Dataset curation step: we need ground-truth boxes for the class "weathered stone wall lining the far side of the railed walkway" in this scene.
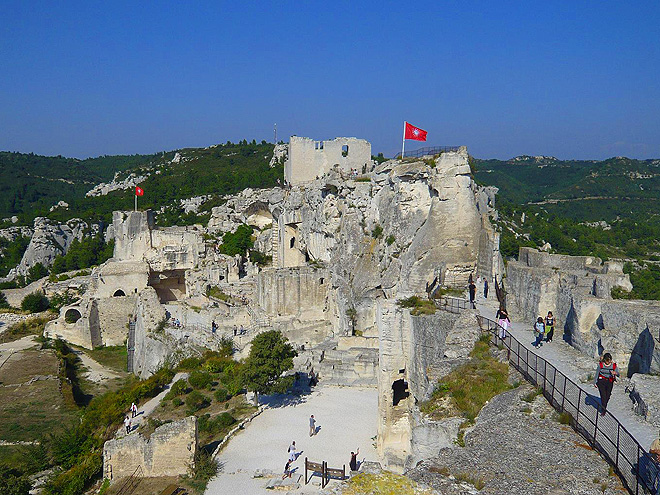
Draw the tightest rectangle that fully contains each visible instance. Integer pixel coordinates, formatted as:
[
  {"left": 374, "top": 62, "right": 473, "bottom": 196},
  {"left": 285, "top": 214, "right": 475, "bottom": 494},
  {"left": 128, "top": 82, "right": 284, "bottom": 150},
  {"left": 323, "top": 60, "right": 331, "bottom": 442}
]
[{"left": 505, "top": 248, "right": 660, "bottom": 374}]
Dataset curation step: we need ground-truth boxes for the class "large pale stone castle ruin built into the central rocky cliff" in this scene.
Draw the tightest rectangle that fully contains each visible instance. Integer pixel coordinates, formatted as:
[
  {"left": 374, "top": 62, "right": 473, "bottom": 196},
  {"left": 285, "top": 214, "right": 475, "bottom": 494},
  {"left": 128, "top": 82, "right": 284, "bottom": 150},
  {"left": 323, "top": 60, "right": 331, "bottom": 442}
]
[{"left": 46, "top": 137, "right": 503, "bottom": 470}]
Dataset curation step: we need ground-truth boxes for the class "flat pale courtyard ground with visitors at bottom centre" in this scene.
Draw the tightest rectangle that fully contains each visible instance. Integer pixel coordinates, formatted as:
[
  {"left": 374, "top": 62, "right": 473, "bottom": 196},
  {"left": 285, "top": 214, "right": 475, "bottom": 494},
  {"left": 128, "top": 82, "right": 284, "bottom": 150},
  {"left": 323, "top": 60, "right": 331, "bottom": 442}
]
[{"left": 206, "top": 386, "right": 378, "bottom": 495}]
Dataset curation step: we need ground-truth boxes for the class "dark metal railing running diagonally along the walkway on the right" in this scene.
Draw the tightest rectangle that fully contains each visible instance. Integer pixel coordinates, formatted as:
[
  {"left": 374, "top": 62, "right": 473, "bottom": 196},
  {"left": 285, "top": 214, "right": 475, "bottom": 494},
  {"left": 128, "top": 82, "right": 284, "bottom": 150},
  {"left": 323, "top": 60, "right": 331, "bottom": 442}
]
[{"left": 477, "top": 315, "right": 660, "bottom": 495}]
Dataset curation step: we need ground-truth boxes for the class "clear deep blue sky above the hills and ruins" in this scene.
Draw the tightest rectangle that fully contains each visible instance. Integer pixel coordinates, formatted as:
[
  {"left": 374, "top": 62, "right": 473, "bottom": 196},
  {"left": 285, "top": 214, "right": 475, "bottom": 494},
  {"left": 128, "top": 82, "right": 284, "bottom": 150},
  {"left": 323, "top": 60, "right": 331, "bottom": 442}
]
[{"left": 0, "top": 0, "right": 660, "bottom": 159}]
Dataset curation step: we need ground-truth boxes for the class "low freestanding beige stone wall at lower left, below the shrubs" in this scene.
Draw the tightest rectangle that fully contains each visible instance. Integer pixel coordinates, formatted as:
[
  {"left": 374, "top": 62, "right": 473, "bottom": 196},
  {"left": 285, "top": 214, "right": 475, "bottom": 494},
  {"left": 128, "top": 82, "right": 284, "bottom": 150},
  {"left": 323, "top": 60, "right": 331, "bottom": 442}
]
[{"left": 103, "top": 416, "right": 197, "bottom": 483}]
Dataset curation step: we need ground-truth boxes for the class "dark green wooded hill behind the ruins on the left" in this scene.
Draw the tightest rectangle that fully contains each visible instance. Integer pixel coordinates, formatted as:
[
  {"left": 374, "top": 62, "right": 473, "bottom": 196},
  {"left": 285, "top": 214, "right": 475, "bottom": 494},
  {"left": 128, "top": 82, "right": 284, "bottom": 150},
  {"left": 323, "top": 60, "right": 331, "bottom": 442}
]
[{"left": 0, "top": 140, "right": 283, "bottom": 228}]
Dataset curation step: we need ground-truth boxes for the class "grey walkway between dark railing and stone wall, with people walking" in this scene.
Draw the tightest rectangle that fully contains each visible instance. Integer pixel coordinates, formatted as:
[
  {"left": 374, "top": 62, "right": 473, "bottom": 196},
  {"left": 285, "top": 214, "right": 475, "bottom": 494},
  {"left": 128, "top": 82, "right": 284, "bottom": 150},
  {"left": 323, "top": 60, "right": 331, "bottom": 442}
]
[{"left": 477, "top": 295, "right": 658, "bottom": 449}]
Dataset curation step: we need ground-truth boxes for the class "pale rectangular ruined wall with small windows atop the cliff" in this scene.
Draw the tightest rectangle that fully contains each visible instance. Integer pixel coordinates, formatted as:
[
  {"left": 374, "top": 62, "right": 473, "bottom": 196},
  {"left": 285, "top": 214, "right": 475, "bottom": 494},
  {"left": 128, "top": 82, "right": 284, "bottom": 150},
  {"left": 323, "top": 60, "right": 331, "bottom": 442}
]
[{"left": 284, "top": 136, "right": 371, "bottom": 185}]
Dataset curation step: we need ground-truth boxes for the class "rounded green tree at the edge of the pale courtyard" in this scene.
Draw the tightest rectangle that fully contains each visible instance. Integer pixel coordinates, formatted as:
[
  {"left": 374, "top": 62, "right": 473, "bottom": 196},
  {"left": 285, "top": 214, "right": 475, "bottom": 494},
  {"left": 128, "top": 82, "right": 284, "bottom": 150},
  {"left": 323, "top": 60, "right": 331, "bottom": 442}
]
[{"left": 241, "top": 330, "right": 298, "bottom": 405}]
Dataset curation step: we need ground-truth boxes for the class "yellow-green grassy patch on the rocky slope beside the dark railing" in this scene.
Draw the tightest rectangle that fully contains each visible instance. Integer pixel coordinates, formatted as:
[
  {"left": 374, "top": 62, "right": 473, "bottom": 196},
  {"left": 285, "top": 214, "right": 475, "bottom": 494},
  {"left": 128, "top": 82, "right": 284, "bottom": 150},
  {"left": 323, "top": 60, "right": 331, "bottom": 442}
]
[{"left": 420, "top": 335, "right": 511, "bottom": 422}]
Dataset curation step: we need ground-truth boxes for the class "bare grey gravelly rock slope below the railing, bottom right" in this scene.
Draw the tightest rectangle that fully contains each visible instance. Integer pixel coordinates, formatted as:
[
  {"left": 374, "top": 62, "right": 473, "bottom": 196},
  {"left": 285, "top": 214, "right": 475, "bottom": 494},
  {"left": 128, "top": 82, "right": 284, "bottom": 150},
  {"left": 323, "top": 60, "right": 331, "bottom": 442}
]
[{"left": 407, "top": 384, "right": 621, "bottom": 495}]
